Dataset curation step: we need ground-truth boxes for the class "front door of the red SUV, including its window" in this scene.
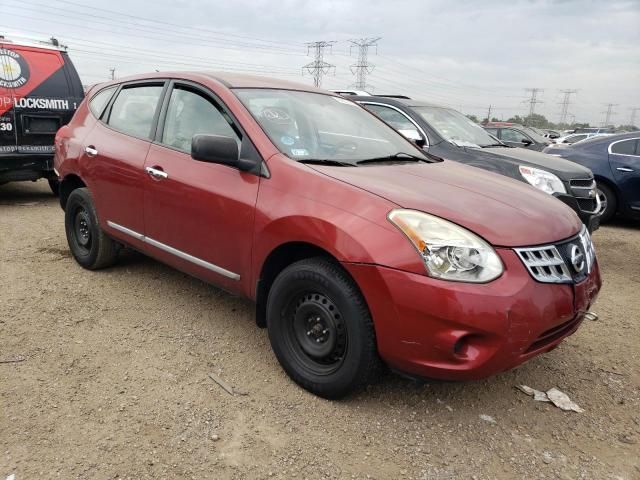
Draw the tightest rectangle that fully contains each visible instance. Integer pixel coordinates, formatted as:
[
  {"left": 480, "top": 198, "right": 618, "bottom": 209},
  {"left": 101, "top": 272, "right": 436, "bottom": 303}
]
[{"left": 144, "top": 82, "right": 259, "bottom": 292}]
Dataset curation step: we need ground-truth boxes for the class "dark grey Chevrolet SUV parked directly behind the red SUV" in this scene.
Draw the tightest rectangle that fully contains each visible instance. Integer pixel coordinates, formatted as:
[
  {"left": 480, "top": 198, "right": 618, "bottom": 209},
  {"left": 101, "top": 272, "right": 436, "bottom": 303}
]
[{"left": 349, "top": 95, "right": 599, "bottom": 231}]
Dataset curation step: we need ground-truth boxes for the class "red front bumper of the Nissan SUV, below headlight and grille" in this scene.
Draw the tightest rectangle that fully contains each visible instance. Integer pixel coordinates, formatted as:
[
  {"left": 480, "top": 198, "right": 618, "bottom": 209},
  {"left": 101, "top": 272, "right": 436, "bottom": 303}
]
[{"left": 344, "top": 249, "right": 601, "bottom": 380}]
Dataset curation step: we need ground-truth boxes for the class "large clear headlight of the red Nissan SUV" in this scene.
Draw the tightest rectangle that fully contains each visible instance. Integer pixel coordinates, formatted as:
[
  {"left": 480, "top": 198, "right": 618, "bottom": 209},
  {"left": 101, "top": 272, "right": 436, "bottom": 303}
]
[{"left": 389, "top": 210, "right": 504, "bottom": 283}]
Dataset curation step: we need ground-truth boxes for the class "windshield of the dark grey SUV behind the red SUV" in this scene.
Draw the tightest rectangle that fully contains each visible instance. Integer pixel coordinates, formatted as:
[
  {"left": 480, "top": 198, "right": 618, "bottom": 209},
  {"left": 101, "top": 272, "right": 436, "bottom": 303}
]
[{"left": 412, "top": 106, "right": 499, "bottom": 147}]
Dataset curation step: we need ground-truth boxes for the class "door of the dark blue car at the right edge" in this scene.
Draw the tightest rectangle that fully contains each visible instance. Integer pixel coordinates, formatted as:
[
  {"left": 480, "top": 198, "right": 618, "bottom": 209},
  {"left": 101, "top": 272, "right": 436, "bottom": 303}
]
[{"left": 609, "top": 137, "right": 640, "bottom": 210}]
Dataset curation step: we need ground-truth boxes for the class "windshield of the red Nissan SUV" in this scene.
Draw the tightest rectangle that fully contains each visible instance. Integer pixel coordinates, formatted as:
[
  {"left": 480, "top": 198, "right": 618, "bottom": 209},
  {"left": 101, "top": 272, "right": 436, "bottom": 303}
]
[{"left": 234, "top": 88, "right": 430, "bottom": 166}]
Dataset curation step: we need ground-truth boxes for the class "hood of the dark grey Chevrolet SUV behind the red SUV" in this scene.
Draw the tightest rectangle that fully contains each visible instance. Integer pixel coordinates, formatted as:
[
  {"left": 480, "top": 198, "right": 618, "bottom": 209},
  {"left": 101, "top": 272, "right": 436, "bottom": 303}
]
[{"left": 474, "top": 145, "right": 593, "bottom": 180}]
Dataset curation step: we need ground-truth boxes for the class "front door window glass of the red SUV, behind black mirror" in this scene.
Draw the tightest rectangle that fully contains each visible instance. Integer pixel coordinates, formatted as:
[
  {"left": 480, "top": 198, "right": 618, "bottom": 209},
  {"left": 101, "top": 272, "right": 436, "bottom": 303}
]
[{"left": 162, "top": 87, "right": 240, "bottom": 154}]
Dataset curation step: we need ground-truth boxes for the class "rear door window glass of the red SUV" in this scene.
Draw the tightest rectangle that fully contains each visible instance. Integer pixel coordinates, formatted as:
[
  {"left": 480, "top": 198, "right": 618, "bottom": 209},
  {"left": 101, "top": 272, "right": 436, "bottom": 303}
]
[{"left": 107, "top": 85, "right": 163, "bottom": 139}]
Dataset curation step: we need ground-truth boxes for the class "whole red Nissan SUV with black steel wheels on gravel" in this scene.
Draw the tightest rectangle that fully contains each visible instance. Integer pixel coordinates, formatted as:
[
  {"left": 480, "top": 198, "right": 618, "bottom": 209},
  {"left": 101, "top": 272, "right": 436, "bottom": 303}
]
[{"left": 55, "top": 73, "right": 601, "bottom": 398}]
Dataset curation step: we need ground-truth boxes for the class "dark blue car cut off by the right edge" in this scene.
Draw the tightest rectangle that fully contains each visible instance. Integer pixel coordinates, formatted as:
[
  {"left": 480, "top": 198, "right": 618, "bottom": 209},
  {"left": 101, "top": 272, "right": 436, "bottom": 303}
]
[{"left": 545, "top": 132, "right": 640, "bottom": 223}]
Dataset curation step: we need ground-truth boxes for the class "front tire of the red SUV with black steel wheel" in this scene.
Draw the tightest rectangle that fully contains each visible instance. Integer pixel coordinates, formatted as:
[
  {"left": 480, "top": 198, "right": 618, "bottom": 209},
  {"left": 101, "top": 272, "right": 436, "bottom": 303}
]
[{"left": 267, "top": 257, "right": 382, "bottom": 399}]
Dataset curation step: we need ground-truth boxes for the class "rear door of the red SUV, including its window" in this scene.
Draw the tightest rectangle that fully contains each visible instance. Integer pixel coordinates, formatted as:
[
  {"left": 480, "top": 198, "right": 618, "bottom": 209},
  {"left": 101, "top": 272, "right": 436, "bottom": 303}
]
[{"left": 80, "top": 81, "right": 166, "bottom": 244}]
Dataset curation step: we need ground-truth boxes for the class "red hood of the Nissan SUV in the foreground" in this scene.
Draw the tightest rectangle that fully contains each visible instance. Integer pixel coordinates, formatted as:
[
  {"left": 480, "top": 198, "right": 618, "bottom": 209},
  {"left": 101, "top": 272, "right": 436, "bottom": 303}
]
[{"left": 310, "top": 160, "right": 582, "bottom": 247}]
